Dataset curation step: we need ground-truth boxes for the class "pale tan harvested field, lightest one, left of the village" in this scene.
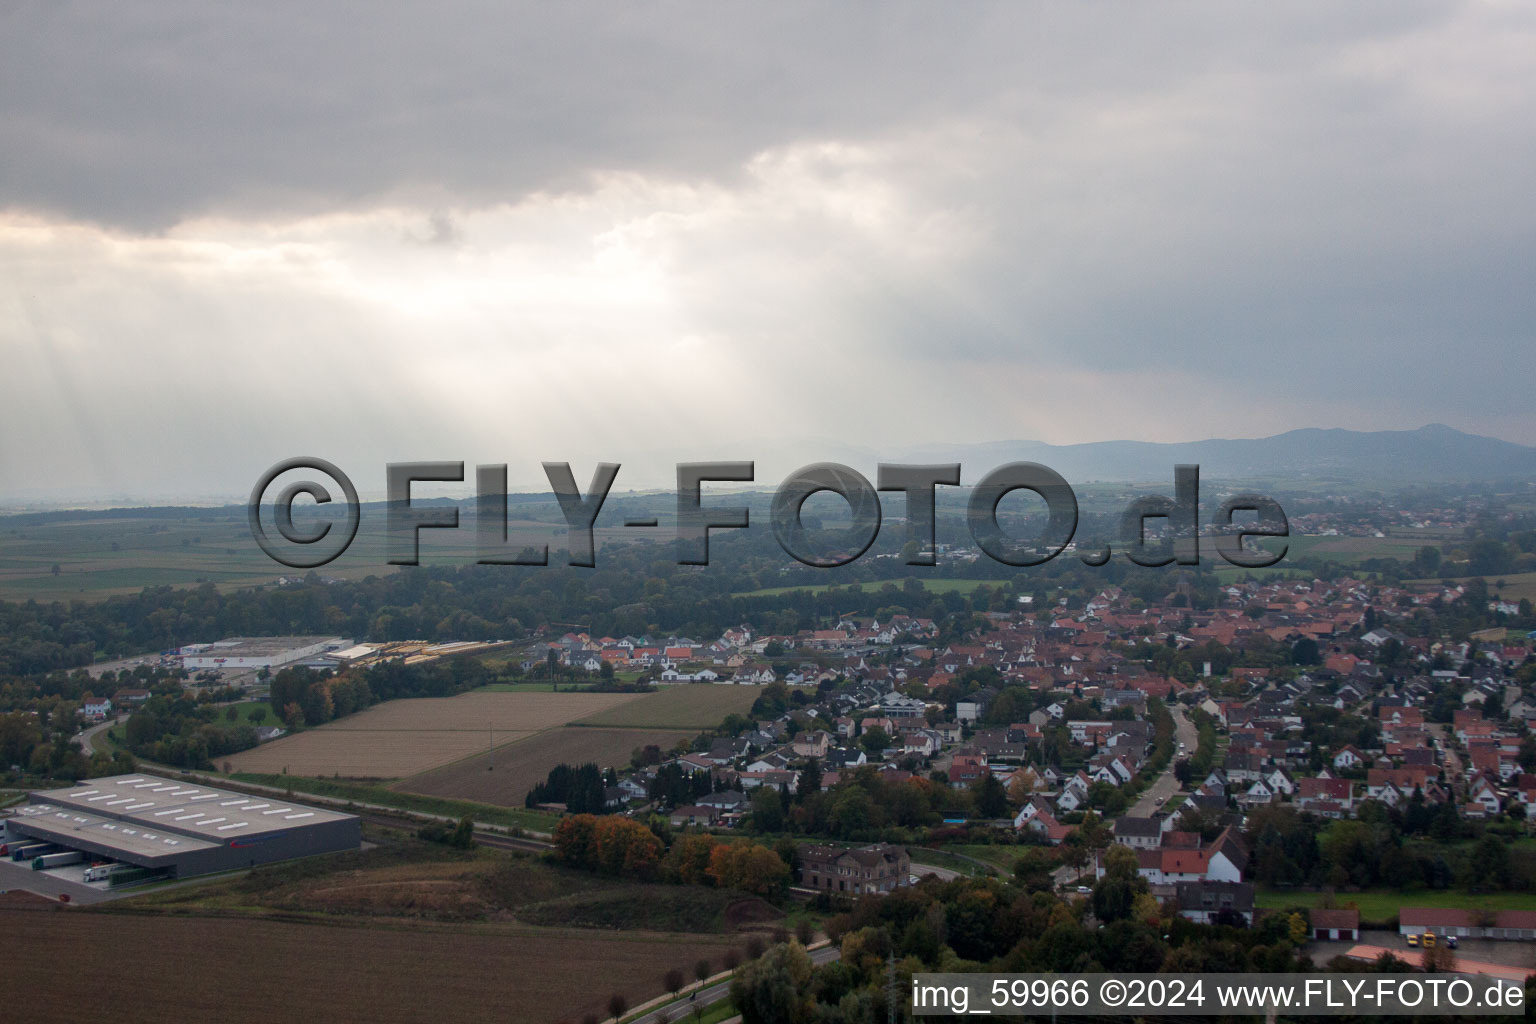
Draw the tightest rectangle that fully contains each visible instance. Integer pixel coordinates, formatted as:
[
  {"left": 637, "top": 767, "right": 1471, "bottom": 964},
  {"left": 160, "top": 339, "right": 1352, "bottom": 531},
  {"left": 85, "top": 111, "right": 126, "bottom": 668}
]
[{"left": 226, "top": 691, "right": 642, "bottom": 779}]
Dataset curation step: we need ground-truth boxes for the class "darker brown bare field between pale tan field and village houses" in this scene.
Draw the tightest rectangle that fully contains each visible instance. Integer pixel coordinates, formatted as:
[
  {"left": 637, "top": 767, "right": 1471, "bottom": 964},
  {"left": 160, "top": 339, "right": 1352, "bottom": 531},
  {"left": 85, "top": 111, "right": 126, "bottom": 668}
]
[{"left": 395, "top": 726, "right": 697, "bottom": 808}]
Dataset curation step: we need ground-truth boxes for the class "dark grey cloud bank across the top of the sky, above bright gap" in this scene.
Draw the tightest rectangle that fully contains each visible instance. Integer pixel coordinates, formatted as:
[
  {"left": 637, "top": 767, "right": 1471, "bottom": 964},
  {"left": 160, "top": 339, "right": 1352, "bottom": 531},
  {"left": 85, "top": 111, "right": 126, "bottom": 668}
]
[{"left": 0, "top": 3, "right": 1444, "bottom": 229}]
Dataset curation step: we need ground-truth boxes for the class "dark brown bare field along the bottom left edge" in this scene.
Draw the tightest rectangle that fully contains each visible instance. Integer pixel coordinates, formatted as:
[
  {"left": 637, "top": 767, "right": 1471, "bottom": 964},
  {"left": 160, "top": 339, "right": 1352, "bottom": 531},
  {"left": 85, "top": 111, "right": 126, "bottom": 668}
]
[{"left": 0, "top": 907, "right": 734, "bottom": 1024}]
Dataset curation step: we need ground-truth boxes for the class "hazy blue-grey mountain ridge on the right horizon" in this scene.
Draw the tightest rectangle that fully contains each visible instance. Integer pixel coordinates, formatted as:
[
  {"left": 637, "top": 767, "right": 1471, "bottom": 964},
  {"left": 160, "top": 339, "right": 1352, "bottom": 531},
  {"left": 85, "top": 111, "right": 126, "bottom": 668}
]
[{"left": 871, "top": 424, "right": 1536, "bottom": 485}]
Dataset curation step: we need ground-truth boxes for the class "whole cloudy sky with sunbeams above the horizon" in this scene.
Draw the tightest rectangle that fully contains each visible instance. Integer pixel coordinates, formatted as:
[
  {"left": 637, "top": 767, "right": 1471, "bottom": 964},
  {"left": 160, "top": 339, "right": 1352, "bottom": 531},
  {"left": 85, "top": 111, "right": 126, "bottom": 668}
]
[{"left": 0, "top": 0, "right": 1536, "bottom": 504}]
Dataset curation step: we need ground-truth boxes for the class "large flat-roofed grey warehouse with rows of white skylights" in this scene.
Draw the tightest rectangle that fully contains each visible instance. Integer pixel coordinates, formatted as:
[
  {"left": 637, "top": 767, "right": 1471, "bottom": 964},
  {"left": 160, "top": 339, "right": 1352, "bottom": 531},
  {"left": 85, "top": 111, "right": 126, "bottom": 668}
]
[{"left": 5, "top": 774, "right": 362, "bottom": 878}]
